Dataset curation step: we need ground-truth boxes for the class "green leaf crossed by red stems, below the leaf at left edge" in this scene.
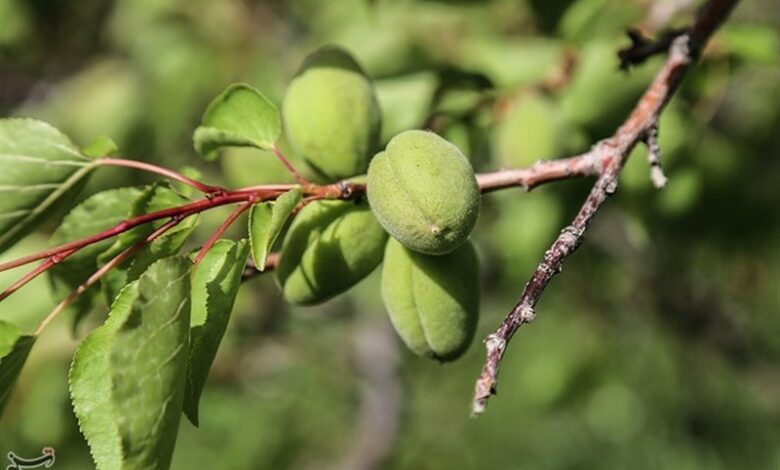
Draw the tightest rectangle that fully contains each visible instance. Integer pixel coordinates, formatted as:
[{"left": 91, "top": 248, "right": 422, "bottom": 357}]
[{"left": 48, "top": 187, "right": 141, "bottom": 330}]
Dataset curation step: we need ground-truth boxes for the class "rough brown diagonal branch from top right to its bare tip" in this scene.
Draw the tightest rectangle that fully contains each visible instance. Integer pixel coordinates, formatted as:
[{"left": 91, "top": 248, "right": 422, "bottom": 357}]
[{"left": 472, "top": 0, "right": 739, "bottom": 414}]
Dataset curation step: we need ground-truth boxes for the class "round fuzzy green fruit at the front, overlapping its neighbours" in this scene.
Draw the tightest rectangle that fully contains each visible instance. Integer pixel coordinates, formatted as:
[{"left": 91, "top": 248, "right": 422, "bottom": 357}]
[{"left": 368, "top": 130, "right": 480, "bottom": 255}]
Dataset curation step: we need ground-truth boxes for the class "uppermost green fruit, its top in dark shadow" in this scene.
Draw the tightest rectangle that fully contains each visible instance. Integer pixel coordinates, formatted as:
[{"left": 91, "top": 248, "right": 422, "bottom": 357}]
[{"left": 282, "top": 47, "right": 381, "bottom": 181}]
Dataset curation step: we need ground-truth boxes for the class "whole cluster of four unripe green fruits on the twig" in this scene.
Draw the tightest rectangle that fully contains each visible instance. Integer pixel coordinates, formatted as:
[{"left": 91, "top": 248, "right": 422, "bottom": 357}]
[{"left": 277, "top": 47, "right": 480, "bottom": 361}]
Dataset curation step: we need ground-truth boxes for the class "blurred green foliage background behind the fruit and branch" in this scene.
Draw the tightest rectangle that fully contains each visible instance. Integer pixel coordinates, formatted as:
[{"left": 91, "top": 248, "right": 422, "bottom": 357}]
[{"left": 0, "top": 0, "right": 780, "bottom": 469}]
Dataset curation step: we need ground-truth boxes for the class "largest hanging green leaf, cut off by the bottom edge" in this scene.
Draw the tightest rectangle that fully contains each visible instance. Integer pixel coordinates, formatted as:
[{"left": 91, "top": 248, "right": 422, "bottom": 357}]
[{"left": 70, "top": 257, "right": 191, "bottom": 470}]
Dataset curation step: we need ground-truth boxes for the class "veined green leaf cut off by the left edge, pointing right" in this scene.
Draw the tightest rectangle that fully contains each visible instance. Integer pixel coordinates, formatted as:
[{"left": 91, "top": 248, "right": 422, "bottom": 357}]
[{"left": 0, "top": 118, "right": 93, "bottom": 252}]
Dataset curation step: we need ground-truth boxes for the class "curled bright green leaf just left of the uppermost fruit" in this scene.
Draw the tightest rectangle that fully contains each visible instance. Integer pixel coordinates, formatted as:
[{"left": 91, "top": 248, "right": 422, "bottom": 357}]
[{"left": 193, "top": 83, "right": 282, "bottom": 159}]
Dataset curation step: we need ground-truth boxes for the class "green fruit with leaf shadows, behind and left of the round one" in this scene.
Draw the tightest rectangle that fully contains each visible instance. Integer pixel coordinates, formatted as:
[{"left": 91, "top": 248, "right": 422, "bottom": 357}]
[{"left": 276, "top": 201, "right": 387, "bottom": 305}]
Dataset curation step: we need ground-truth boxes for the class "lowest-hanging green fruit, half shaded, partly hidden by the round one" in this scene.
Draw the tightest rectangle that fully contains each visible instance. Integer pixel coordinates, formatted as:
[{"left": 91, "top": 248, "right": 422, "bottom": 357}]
[{"left": 382, "top": 239, "right": 479, "bottom": 362}]
